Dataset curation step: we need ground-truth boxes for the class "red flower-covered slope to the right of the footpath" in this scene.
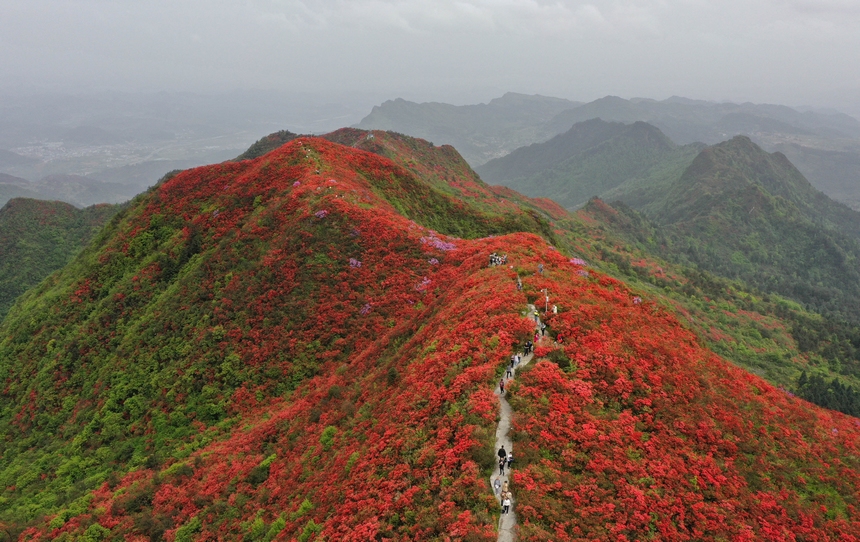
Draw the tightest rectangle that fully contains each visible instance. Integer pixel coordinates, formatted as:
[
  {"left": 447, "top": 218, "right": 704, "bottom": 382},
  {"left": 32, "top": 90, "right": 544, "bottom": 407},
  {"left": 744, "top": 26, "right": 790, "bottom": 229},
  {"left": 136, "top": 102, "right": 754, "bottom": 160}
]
[{"left": 508, "top": 251, "right": 860, "bottom": 540}]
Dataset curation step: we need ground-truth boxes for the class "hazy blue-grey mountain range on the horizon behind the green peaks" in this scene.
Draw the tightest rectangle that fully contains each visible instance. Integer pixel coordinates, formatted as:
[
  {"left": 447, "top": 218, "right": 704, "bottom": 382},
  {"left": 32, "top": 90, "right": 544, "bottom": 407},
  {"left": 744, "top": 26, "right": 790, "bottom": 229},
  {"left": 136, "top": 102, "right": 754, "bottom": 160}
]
[{"left": 357, "top": 94, "right": 860, "bottom": 208}]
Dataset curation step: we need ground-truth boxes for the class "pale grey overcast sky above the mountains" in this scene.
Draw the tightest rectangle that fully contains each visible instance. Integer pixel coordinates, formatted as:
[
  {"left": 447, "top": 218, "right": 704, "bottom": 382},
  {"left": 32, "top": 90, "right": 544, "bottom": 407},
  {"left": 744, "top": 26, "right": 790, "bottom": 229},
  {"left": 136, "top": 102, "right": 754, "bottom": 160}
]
[{"left": 0, "top": 0, "right": 860, "bottom": 111}]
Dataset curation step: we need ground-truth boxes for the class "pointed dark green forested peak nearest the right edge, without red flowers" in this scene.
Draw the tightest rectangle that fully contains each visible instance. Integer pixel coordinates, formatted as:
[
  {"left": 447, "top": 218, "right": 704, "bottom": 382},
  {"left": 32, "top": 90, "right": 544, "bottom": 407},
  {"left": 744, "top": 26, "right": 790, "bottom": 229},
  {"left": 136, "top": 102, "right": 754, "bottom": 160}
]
[{"left": 644, "top": 137, "right": 860, "bottom": 322}]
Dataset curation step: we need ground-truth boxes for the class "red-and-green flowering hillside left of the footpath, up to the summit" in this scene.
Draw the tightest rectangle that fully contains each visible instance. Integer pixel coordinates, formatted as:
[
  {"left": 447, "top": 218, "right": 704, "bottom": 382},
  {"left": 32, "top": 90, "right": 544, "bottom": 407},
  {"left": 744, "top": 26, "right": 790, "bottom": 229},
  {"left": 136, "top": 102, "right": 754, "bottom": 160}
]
[{"left": 0, "top": 139, "right": 544, "bottom": 539}]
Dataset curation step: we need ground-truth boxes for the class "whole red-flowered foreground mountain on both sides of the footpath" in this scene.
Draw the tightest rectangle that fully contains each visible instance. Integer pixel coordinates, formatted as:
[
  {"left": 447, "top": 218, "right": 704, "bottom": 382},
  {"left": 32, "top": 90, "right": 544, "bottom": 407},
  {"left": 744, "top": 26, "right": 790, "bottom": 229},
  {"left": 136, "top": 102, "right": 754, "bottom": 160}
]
[{"left": 0, "top": 136, "right": 860, "bottom": 541}]
